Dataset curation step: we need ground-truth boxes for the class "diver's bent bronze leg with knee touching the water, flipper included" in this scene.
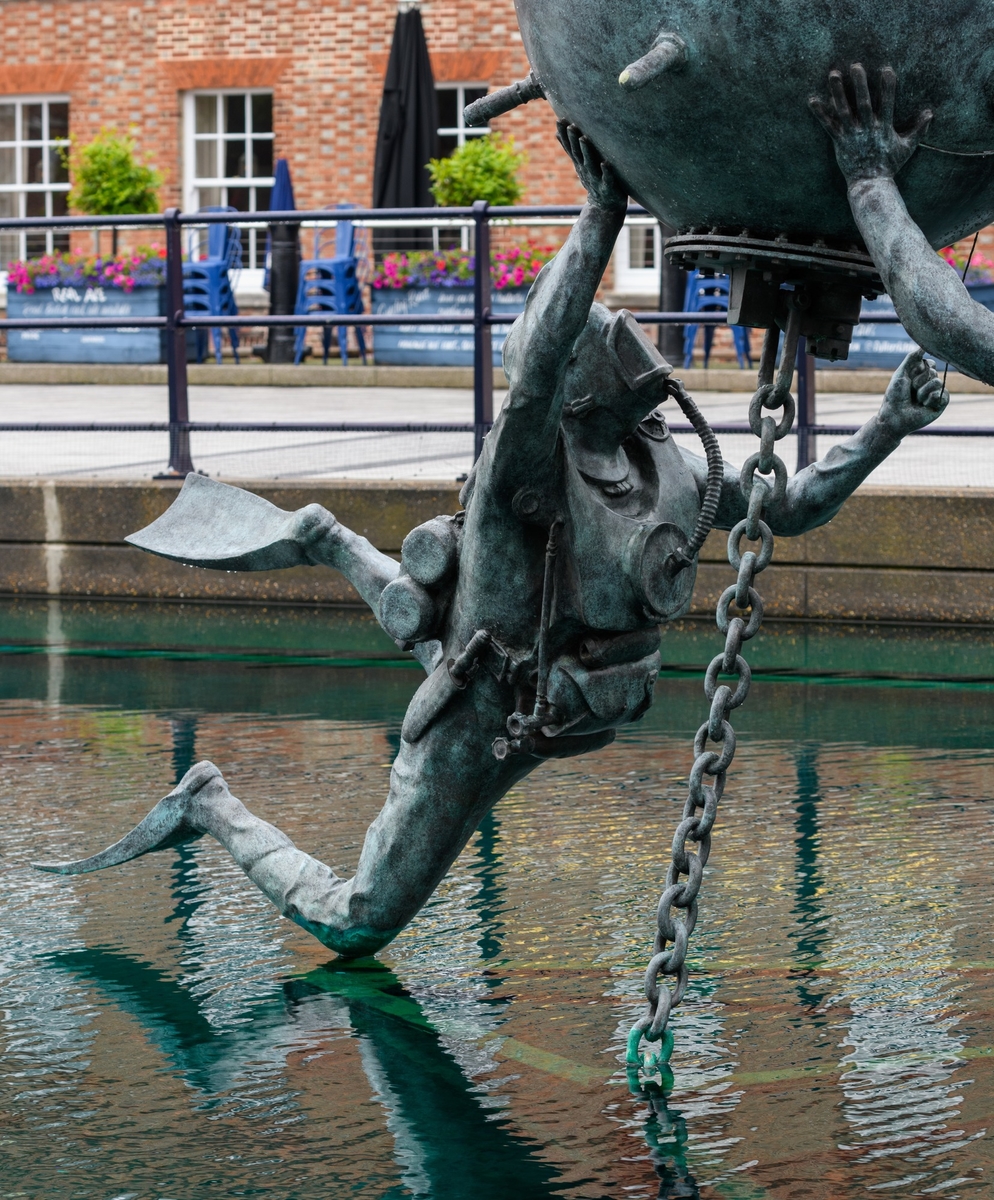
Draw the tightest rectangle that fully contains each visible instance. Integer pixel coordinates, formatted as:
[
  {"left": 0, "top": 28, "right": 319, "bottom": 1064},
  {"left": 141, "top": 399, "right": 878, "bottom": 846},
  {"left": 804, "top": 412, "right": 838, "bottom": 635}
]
[{"left": 36, "top": 676, "right": 538, "bottom": 956}]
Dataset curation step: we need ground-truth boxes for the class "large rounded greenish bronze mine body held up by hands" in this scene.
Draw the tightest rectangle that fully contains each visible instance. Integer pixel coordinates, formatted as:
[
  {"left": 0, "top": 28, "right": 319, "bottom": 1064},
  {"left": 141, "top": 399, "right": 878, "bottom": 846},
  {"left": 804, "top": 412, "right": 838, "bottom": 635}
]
[{"left": 504, "top": 0, "right": 994, "bottom": 247}]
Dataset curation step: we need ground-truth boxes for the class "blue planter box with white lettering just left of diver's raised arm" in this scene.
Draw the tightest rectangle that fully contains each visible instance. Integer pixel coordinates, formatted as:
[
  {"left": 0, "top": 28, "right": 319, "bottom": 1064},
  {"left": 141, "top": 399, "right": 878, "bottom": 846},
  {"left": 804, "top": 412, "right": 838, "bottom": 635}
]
[{"left": 372, "top": 288, "right": 528, "bottom": 367}]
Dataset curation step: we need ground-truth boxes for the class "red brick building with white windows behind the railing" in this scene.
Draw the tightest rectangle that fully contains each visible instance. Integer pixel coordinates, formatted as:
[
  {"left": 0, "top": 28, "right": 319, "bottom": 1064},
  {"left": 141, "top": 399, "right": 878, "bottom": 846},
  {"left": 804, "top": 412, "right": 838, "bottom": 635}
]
[{"left": 0, "top": 0, "right": 658, "bottom": 304}]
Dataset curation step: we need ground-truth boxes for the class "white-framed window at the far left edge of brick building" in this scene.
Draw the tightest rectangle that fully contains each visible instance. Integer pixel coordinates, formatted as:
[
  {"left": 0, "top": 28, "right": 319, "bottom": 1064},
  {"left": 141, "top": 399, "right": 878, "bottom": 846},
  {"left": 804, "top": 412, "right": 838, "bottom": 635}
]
[{"left": 0, "top": 96, "right": 70, "bottom": 268}]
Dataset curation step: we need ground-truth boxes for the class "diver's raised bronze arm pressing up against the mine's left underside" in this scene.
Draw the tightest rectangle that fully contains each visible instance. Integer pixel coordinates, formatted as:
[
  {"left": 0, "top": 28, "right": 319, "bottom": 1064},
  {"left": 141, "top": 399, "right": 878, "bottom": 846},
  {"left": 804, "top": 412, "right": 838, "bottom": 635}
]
[{"left": 499, "top": 121, "right": 628, "bottom": 477}]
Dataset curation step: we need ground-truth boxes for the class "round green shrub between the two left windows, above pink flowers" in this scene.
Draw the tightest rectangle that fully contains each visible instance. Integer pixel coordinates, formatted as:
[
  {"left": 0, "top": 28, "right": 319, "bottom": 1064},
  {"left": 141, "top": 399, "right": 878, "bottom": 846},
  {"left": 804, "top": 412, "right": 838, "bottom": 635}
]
[{"left": 68, "top": 130, "right": 162, "bottom": 216}]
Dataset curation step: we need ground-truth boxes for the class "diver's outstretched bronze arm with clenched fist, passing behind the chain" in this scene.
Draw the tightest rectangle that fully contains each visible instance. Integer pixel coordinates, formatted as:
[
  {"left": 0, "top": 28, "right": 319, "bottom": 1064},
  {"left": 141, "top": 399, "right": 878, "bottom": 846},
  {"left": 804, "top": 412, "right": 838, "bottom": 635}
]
[{"left": 683, "top": 350, "right": 950, "bottom": 538}]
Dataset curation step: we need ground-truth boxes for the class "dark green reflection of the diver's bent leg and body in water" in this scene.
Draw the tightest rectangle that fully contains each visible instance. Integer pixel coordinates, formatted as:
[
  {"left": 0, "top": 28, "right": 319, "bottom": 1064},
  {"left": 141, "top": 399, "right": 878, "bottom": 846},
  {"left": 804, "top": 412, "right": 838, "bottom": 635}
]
[{"left": 48, "top": 948, "right": 566, "bottom": 1200}]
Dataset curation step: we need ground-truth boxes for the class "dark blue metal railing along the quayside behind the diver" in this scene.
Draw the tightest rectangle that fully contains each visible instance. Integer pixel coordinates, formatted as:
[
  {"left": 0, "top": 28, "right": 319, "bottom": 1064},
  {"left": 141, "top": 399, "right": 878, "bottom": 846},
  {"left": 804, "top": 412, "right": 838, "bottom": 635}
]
[{"left": 0, "top": 200, "right": 979, "bottom": 476}]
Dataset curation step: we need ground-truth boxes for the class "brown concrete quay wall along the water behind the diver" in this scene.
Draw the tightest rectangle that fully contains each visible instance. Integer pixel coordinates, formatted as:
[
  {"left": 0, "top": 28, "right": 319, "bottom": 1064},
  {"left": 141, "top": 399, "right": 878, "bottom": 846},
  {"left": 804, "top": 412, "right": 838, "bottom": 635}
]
[{"left": 0, "top": 479, "right": 994, "bottom": 625}]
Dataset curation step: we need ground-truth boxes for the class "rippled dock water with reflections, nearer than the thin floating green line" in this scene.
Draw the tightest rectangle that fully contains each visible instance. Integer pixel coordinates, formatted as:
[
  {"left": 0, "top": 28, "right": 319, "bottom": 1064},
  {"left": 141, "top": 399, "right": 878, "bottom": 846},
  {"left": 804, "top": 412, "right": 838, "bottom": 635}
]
[{"left": 0, "top": 609, "right": 994, "bottom": 1200}]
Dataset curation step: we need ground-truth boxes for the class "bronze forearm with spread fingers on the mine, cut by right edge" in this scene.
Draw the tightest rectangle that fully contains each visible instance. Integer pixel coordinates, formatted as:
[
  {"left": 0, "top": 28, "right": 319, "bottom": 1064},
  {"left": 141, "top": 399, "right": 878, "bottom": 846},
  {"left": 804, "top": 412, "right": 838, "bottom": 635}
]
[{"left": 810, "top": 62, "right": 994, "bottom": 383}]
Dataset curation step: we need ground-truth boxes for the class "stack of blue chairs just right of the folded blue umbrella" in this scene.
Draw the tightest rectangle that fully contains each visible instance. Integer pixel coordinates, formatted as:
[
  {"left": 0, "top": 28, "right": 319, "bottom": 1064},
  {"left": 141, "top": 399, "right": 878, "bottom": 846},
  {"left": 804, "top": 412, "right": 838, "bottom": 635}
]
[{"left": 294, "top": 204, "right": 366, "bottom": 366}]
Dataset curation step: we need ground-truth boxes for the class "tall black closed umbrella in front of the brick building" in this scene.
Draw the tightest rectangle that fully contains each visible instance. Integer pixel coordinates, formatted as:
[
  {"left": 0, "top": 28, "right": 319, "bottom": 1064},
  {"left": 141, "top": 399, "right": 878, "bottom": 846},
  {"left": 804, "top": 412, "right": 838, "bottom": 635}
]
[{"left": 373, "top": 5, "right": 438, "bottom": 251}]
